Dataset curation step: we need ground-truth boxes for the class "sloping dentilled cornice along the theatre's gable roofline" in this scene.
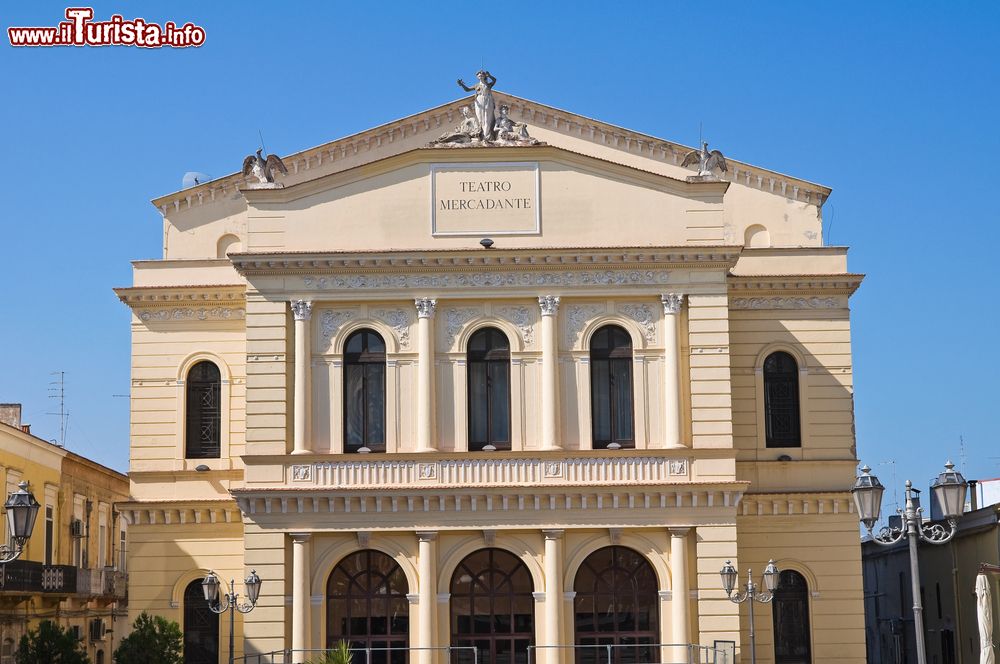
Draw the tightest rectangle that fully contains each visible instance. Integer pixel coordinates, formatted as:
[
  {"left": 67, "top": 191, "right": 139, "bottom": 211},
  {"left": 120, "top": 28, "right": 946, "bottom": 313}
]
[{"left": 152, "top": 90, "right": 831, "bottom": 216}]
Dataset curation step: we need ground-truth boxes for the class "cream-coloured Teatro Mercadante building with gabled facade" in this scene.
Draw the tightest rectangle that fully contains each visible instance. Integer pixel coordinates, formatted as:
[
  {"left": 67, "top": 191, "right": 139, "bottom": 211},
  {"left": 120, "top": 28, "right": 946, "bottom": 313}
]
[{"left": 116, "top": 85, "right": 865, "bottom": 664}]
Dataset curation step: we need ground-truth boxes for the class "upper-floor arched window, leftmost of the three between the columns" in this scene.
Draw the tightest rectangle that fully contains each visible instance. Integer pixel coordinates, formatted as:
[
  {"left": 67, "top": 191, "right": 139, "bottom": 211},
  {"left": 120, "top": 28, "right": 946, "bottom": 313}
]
[{"left": 344, "top": 330, "right": 385, "bottom": 452}]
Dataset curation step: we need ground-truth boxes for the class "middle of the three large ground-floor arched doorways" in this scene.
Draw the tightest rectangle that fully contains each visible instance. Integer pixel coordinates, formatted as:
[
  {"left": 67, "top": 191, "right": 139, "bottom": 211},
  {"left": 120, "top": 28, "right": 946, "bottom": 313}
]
[{"left": 451, "top": 549, "right": 535, "bottom": 664}]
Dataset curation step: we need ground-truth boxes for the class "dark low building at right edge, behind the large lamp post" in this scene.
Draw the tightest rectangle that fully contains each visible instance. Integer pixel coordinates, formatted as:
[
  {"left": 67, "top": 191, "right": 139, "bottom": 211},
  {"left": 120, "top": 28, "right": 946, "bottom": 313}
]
[{"left": 861, "top": 498, "right": 1000, "bottom": 664}]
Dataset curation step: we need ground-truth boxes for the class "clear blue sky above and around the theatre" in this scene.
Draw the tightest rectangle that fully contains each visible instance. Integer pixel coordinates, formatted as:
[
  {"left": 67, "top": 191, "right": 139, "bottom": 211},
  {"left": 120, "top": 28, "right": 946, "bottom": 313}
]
[{"left": 0, "top": 2, "right": 1000, "bottom": 504}]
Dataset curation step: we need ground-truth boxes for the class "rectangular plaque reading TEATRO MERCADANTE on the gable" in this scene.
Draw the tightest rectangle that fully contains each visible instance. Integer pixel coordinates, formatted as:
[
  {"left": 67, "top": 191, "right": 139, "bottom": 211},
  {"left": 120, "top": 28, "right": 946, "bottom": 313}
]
[{"left": 431, "top": 162, "right": 541, "bottom": 237}]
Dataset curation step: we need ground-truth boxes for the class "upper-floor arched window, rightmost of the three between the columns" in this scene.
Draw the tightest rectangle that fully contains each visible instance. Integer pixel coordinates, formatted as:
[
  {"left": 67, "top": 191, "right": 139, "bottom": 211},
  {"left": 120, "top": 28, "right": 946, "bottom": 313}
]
[{"left": 590, "top": 325, "right": 635, "bottom": 449}]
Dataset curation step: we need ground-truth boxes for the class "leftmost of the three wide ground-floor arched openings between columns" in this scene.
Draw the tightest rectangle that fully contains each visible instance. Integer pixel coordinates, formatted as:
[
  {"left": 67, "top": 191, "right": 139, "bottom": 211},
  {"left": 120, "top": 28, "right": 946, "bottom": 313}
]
[{"left": 326, "top": 549, "right": 410, "bottom": 664}]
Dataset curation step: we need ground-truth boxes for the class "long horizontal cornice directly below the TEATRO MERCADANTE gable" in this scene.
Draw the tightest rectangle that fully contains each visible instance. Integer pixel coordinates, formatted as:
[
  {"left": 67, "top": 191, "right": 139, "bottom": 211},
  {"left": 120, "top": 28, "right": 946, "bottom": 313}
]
[{"left": 230, "top": 246, "right": 740, "bottom": 276}]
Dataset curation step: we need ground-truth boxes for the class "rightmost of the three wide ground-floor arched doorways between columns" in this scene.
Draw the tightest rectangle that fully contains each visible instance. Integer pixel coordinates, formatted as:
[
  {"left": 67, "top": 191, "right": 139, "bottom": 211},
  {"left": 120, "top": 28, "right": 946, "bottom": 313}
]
[{"left": 573, "top": 546, "right": 660, "bottom": 664}]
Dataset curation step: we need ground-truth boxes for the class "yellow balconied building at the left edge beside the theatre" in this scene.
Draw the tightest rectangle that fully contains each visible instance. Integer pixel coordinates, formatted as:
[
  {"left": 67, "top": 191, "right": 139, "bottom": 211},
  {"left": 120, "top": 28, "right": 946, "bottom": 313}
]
[{"left": 0, "top": 404, "right": 128, "bottom": 664}]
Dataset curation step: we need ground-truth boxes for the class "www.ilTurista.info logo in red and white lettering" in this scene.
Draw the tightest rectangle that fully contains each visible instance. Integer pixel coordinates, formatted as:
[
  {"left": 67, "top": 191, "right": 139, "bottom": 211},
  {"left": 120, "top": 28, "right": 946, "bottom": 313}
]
[{"left": 7, "top": 7, "right": 205, "bottom": 48}]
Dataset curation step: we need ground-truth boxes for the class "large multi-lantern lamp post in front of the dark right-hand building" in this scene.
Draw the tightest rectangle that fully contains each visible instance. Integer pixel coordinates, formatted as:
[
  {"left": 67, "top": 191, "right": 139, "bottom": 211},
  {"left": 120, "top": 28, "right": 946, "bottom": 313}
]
[{"left": 851, "top": 461, "right": 968, "bottom": 664}]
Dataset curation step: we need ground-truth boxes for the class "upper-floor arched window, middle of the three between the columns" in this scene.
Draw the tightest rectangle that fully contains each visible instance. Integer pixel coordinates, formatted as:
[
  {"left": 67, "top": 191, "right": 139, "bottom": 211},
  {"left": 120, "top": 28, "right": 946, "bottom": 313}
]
[{"left": 468, "top": 327, "right": 510, "bottom": 450}]
